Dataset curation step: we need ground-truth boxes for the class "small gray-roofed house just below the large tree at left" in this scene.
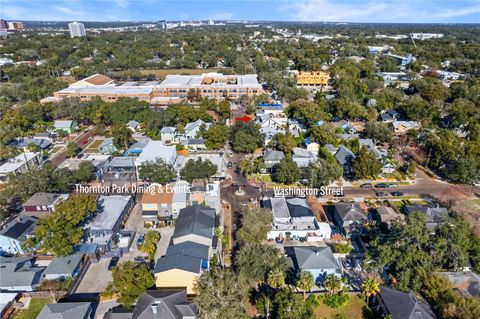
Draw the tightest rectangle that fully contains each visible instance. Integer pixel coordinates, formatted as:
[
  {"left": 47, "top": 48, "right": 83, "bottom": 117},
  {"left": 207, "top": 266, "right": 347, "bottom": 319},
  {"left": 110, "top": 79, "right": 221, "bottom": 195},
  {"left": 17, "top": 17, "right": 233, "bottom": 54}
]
[{"left": 43, "top": 254, "right": 83, "bottom": 280}]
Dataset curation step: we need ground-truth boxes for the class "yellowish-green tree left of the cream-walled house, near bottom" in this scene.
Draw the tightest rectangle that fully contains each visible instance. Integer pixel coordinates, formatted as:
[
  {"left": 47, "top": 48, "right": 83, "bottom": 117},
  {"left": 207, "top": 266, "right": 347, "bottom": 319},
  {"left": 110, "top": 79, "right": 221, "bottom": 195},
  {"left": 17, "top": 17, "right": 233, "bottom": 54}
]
[{"left": 102, "top": 261, "right": 155, "bottom": 307}]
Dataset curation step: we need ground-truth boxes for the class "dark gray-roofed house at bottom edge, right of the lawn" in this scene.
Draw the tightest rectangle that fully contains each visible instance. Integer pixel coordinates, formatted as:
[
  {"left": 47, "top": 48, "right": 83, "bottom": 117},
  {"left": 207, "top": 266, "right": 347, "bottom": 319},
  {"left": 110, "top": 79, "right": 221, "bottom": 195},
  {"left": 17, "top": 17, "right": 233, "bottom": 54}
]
[{"left": 374, "top": 285, "right": 437, "bottom": 319}]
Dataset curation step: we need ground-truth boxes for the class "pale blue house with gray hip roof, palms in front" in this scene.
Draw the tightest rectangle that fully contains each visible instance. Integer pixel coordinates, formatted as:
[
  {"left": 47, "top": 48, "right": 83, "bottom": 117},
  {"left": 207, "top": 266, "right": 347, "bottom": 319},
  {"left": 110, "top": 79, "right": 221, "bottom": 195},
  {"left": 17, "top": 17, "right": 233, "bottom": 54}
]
[{"left": 285, "top": 246, "right": 343, "bottom": 285}]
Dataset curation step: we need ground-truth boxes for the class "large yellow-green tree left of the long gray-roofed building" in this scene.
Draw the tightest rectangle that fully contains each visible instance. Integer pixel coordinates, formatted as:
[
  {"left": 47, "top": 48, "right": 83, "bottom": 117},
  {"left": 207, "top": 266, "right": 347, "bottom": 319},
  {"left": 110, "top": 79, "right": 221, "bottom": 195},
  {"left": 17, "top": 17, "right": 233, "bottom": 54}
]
[{"left": 25, "top": 195, "right": 96, "bottom": 256}]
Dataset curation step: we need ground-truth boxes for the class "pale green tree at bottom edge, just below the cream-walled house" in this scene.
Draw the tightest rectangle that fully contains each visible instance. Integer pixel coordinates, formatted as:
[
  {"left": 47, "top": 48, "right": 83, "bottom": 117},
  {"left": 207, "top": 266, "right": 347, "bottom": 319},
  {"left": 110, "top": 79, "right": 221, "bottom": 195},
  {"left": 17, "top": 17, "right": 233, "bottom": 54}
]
[{"left": 195, "top": 269, "right": 248, "bottom": 319}]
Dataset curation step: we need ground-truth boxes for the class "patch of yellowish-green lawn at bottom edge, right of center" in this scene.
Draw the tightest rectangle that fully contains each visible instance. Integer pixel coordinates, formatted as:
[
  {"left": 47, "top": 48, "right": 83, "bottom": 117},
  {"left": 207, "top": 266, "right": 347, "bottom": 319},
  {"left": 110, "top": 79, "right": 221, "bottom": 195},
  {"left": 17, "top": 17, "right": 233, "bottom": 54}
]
[{"left": 315, "top": 296, "right": 379, "bottom": 319}]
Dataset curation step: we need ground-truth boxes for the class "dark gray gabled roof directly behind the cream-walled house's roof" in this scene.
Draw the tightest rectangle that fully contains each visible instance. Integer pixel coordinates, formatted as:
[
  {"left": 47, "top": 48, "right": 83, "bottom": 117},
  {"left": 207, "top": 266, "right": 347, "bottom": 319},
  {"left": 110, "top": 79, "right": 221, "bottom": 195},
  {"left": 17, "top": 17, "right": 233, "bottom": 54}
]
[{"left": 172, "top": 205, "right": 215, "bottom": 238}]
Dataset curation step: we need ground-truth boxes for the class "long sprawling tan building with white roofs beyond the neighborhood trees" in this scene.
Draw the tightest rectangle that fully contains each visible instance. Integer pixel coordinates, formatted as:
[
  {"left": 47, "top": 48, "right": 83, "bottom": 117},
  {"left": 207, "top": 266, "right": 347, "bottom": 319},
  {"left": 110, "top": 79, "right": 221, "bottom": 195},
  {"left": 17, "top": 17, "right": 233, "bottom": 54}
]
[{"left": 49, "top": 73, "right": 263, "bottom": 104}]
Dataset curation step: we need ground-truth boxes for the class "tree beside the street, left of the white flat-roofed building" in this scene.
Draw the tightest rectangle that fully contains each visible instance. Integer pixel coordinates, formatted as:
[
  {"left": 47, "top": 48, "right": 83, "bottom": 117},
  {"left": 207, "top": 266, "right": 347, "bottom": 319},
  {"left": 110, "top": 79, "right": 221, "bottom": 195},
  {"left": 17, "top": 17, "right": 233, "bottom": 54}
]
[{"left": 237, "top": 208, "right": 272, "bottom": 245}]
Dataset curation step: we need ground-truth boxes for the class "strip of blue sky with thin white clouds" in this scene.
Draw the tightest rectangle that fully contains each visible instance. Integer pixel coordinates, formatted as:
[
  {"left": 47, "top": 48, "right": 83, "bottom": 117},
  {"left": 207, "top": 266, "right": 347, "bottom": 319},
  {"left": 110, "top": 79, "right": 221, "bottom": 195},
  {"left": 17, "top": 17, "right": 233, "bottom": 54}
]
[{"left": 0, "top": 0, "right": 480, "bottom": 23}]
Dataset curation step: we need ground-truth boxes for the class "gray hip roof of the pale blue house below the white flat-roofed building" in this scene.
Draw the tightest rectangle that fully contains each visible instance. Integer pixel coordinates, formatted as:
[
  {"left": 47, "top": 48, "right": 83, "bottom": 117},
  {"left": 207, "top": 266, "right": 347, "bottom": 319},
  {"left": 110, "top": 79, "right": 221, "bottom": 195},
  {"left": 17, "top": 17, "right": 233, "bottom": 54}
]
[{"left": 293, "top": 246, "right": 340, "bottom": 270}]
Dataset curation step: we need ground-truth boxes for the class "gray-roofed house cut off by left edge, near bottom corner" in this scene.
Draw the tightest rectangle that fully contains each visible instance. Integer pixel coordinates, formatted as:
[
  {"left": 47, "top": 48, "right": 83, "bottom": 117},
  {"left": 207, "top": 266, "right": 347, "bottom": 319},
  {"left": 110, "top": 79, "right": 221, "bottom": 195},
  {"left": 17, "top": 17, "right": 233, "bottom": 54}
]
[{"left": 0, "top": 256, "right": 45, "bottom": 291}]
